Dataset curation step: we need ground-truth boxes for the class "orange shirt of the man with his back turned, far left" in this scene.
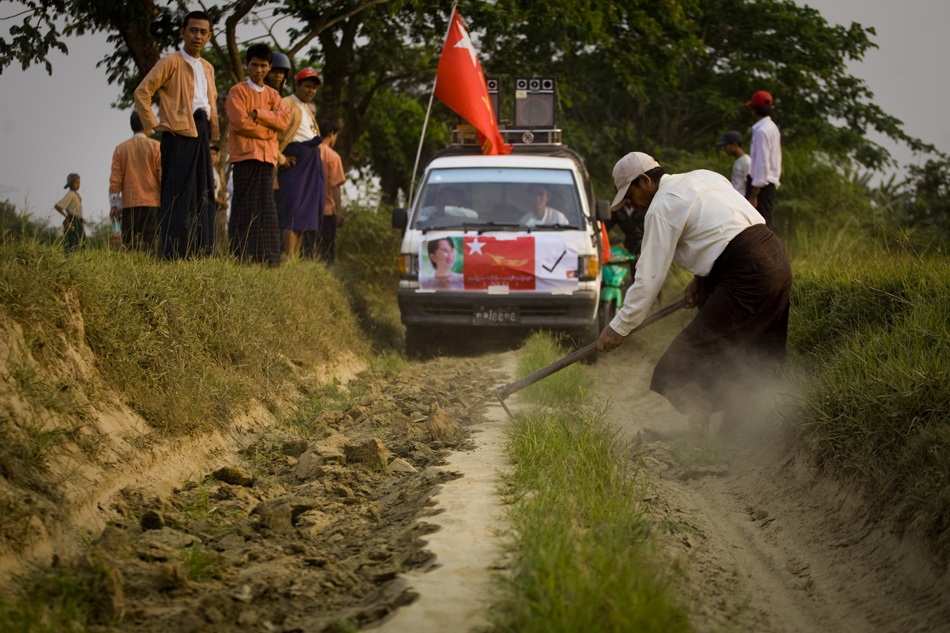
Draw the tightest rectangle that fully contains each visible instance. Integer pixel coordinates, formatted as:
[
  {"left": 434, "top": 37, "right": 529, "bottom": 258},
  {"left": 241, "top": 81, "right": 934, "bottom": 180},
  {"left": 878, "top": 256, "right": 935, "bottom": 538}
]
[{"left": 109, "top": 134, "right": 162, "bottom": 208}]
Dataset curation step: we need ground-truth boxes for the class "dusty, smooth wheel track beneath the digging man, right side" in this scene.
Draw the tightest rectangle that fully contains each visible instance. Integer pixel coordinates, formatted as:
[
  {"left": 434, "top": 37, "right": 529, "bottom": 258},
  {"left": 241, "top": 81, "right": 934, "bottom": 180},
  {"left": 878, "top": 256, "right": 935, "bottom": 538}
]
[{"left": 593, "top": 340, "right": 950, "bottom": 633}]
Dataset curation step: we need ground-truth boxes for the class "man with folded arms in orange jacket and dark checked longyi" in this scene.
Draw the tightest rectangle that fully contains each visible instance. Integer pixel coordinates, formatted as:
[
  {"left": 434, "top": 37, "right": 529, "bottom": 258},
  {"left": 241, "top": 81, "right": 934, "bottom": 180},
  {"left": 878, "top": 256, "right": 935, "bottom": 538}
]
[{"left": 225, "top": 44, "right": 290, "bottom": 266}]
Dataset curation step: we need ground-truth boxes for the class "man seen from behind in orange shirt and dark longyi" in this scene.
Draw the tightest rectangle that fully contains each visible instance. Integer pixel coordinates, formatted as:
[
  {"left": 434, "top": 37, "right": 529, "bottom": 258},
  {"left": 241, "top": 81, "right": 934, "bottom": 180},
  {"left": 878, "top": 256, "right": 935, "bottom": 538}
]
[{"left": 109, "top": 111, "right": 162, "bottom": 252}]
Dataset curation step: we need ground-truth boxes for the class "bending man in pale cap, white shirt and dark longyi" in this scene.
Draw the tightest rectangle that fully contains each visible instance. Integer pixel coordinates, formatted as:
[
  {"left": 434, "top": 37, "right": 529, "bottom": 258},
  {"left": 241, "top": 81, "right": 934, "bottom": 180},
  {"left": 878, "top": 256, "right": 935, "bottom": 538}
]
[{"left": 597, "top": 152, "right": 792, "bottom": 435}]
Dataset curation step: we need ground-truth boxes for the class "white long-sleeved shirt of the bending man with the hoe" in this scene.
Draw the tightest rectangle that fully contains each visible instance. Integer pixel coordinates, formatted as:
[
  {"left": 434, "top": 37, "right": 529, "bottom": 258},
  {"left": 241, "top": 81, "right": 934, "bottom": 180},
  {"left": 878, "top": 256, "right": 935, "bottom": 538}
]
[{"left": 610, "top": 169, "right": 765, "bottom": 336}]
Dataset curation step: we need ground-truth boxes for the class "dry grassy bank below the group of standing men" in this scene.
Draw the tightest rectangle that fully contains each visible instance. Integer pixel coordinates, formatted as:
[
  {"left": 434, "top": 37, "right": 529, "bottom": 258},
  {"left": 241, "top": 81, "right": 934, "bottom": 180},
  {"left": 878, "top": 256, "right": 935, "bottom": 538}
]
[{"left": 0, "top": 241, "right": 365, "bottom": 433}]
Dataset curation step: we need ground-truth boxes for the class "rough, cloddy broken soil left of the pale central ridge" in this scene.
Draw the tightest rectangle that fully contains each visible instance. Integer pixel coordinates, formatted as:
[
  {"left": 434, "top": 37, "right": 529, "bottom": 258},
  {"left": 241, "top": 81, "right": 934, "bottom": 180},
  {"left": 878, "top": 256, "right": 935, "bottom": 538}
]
[{"left": 4, "top": 340, "right": 503, "bottom": 633}]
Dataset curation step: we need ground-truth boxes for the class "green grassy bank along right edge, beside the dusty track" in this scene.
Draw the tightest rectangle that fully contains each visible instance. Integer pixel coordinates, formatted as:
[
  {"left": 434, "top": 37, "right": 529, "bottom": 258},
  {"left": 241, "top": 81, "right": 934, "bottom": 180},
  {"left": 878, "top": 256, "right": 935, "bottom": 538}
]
[{"left": 790, "top": 252, "right": 950, "bottom": 559}]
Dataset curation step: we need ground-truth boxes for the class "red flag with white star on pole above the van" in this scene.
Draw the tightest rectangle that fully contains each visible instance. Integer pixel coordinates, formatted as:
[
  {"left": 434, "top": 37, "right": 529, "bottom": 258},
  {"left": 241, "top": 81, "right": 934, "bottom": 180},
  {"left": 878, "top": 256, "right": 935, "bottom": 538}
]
[{"left": 435, "top": 11, "right": 511, "bottom": 154}]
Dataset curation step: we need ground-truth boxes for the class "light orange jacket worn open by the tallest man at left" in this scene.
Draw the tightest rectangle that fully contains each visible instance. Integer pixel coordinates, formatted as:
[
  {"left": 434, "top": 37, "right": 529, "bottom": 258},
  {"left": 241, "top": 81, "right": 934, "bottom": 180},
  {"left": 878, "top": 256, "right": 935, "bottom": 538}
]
[{"left": 133, "top": 51, "right": 219, "bottom": 141}]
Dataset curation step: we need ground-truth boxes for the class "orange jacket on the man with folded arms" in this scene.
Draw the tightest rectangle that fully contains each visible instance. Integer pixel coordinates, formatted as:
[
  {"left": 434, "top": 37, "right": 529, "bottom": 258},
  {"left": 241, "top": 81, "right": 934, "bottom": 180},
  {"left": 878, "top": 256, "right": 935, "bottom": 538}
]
[{"left": 225, "top": 81, "right": 290, "bottom": 165}]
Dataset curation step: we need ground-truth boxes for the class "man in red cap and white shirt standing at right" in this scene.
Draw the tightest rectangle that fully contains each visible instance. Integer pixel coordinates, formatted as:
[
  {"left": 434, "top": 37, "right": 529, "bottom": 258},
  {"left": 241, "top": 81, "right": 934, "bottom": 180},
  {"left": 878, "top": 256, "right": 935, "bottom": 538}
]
[{"left": 746, "top": 90, "right": 782, "bottom": 231}]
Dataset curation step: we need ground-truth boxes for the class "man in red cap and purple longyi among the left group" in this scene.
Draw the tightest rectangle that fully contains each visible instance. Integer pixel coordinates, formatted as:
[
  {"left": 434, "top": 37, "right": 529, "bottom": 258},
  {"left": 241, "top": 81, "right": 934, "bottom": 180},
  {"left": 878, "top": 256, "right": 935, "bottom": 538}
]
[{"left": 277, "top": 68, "right": 327, "bottom": 259}]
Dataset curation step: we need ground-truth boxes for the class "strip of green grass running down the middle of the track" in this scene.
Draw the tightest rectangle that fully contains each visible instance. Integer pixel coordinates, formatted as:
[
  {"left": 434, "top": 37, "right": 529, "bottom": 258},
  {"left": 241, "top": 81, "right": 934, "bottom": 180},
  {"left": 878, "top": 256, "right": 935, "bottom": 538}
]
[{"left": 488, "top": 336, "right": 690, "bottom": 633}]
